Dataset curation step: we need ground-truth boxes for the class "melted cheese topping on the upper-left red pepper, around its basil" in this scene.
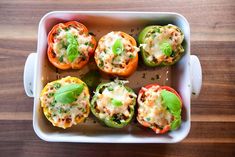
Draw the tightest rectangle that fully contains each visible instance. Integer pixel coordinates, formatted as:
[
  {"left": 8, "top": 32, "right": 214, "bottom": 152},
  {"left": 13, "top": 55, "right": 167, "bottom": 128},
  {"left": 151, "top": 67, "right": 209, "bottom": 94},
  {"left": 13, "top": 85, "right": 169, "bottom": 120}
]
[{"left": 52, "top": 27, "right": 94, "bottom": 63}]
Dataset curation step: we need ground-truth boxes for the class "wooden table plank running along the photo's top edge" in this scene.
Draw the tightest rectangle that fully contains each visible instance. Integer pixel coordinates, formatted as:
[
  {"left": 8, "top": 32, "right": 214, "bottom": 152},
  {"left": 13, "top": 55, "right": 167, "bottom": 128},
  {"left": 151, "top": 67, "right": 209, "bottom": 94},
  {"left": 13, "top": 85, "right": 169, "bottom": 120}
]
[{"left": 0, "top": 0, "right": 235, "bottom": 41}]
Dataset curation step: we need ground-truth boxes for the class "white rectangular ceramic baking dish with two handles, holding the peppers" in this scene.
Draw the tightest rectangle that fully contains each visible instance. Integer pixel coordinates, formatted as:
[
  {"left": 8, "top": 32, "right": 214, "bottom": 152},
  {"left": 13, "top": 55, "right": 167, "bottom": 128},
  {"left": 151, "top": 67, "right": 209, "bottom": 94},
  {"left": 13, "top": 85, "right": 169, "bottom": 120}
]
[{"left": 24, "top": 11, "right": 202, "bottom": 143}]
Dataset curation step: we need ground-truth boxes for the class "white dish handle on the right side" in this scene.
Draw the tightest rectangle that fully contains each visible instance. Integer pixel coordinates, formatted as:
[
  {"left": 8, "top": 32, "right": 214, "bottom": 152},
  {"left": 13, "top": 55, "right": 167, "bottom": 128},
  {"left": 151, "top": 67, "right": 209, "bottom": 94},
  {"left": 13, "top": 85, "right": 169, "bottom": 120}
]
[{"left": 190, "top": 55, "right": 202, "bottom": 98}]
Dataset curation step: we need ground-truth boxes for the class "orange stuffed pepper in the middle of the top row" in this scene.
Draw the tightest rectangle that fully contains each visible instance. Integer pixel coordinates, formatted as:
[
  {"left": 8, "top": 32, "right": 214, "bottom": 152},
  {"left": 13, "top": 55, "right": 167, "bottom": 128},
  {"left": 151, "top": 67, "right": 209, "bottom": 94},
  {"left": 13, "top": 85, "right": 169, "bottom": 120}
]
[{"left": 95, "top": 31, "right": 139, "bottom": 77}]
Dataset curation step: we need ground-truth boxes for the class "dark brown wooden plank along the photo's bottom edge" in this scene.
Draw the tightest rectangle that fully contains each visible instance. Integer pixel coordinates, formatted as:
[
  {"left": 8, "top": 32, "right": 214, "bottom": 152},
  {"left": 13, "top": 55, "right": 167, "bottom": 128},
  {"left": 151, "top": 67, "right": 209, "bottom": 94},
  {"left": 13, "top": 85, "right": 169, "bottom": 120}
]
[{"left": 0, "top": 141, "right": 235, "bottom": 157}]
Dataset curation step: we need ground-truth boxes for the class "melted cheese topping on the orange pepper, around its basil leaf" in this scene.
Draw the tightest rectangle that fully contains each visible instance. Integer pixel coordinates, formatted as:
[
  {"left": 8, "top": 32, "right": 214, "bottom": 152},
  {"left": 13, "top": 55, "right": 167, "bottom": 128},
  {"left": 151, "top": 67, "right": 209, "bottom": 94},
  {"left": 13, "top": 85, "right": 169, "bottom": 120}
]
[{"left": 95, "top": 32, "right": 139, "bottom": 72}]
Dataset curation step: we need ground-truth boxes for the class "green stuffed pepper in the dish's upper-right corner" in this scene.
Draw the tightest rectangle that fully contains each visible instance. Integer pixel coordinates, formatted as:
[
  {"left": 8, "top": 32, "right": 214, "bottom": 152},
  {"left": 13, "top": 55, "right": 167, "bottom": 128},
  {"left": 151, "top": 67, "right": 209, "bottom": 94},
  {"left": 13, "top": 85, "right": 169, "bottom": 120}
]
[{"left": 138, "top": 24, "right": 184, "bottom": 67}]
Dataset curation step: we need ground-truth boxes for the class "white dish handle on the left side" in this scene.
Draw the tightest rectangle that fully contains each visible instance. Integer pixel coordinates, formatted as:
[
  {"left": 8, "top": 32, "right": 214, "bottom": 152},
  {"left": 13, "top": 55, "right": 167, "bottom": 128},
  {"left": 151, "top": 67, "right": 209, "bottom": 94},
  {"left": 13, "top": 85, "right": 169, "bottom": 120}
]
[{"left": 24, "top": 53, "right": 37, "bottom": 97}]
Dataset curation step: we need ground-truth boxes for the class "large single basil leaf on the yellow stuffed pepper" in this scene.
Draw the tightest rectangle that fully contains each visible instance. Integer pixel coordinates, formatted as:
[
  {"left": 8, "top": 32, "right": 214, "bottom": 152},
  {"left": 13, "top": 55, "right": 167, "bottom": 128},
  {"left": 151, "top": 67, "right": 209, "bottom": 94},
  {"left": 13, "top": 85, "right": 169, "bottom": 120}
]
[{"left": 55, "top": 84, "right": 84, "bottom": 104}]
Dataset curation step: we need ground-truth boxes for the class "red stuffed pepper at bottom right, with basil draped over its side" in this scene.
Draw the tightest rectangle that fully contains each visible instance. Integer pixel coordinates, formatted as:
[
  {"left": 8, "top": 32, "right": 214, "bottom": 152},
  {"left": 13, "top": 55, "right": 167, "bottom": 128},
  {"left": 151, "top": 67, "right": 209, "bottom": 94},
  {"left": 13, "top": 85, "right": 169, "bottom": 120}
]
[{"left": 137, "top": 84, "right": 182, "bottom": 134}]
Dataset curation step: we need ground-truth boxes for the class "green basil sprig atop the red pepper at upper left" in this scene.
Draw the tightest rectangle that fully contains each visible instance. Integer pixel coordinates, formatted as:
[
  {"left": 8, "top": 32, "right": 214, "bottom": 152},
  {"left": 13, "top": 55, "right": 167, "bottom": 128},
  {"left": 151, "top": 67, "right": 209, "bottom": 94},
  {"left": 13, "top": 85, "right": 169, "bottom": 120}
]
[{"left": 66, "top": 33, "right": 80, "bottom": 62}]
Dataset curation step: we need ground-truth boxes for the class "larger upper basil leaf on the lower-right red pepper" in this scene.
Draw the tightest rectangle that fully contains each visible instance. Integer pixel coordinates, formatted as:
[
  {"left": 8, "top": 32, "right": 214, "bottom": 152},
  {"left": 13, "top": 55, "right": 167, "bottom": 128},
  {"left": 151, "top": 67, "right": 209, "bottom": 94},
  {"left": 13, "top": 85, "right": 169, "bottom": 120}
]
[{"left": 161, "top": 90, "right": 181, "bottom": 116}]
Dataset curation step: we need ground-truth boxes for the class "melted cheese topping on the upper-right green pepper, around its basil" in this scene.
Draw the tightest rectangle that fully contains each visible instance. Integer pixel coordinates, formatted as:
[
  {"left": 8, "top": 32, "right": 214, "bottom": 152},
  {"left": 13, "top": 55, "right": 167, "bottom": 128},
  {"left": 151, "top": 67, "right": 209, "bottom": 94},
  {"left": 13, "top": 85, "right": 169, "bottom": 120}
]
[{"left": 142, "top": 24, "right": 184, "bottom": 63}]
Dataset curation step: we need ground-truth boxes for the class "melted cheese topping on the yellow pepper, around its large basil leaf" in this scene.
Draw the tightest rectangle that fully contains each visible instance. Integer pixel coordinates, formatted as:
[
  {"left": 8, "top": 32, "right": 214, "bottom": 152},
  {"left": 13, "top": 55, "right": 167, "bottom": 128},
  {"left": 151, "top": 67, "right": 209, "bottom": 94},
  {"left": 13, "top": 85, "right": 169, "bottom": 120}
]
[{"left": 40, "top": 76, "right": 90, "bottom": 128}]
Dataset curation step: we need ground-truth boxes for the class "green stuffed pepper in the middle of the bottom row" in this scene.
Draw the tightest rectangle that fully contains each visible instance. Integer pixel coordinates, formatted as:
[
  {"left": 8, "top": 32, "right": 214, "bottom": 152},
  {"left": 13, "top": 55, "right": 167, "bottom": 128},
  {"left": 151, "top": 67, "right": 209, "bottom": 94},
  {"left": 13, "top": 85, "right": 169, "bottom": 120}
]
[{"left": 91, "top": 80, "right": 137, "bottom": 128}]
